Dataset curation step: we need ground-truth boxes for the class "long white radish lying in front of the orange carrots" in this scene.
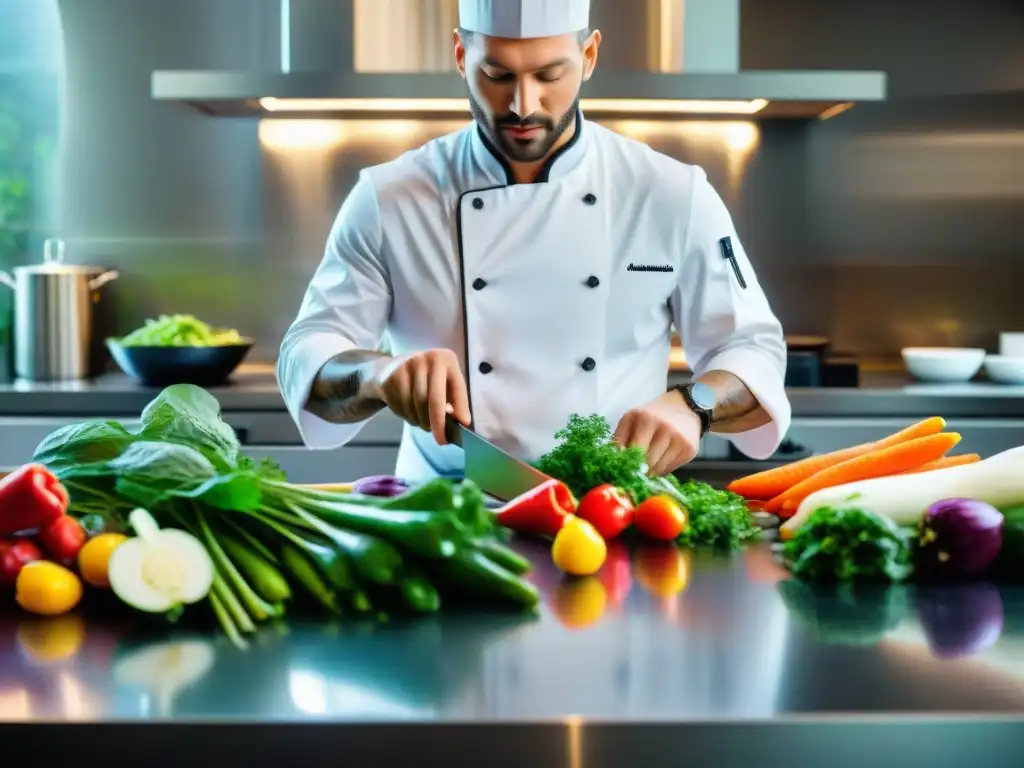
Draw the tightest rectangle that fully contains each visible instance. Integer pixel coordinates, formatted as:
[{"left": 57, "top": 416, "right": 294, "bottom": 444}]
[{"left": 780, "top": 445, "right": 1024, "bottom": 538}]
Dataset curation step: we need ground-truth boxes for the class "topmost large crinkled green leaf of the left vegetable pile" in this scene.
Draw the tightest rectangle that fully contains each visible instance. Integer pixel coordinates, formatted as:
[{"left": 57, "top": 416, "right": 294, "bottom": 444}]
[{"left": 138, "top": 384, "right": 241, "bottom": 471}]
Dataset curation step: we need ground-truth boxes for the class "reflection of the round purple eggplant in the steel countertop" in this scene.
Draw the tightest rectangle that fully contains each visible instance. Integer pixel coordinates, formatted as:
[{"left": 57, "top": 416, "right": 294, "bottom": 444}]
[{"left": 914, "top": 582, "right": 1005, "bottom": 658}]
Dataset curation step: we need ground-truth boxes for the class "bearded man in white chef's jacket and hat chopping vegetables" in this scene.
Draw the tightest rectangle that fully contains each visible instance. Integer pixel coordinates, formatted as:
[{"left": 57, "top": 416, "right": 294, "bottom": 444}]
[{"left": 278, "top": 0, "right": 790, "bottom": 480}]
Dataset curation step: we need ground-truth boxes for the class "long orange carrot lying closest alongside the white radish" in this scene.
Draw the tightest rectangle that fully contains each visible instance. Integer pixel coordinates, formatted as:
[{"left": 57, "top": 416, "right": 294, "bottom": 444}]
[{"left": 765, "top": 432, "right": 961, "bottom": 513}]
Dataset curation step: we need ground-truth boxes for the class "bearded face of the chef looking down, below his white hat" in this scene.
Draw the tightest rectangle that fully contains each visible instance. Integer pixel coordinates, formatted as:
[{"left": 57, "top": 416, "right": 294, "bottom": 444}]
[{"left": 455, "top": 31, "right": 601, "bottom": 163}]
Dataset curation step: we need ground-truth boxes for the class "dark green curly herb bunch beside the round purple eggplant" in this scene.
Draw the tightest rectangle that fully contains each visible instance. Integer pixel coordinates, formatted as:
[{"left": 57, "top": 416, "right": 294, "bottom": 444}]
[{"left": 782, "top": 507, "right": 913, "bottom": 582}]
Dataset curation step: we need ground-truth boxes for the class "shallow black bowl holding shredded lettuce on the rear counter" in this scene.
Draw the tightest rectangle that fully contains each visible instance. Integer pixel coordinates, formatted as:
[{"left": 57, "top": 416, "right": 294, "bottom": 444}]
[{"left": 106, "top": 339, "right": 253, "bottom": 387}]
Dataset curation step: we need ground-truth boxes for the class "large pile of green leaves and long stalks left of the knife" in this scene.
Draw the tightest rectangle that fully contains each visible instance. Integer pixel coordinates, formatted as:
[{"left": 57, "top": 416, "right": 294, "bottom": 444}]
[{"left": 33, "top": 384, "right": 538, "bottom": 646}]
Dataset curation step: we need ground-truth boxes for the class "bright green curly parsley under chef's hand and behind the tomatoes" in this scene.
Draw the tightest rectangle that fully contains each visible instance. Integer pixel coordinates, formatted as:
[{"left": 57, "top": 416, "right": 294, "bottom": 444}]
[{"left": 537, "top": 414, "right": 761, "bottom": 550}]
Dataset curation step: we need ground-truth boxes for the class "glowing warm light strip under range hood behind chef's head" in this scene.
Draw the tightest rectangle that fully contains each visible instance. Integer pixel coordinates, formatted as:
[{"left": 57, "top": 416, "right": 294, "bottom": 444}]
[{"left": 259, "top": 96, "right": 768, "bottom": 115}]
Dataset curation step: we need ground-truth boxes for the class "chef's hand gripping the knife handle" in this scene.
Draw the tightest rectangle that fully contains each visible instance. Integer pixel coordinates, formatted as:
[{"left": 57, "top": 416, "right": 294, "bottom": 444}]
[{"left": 374, "top": 349, "right": 472, "bottom": 445}]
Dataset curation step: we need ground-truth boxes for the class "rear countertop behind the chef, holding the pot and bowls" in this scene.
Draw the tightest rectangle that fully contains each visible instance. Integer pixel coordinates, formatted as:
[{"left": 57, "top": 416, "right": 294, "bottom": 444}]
[{"left": 0, "top": 366, "right": 1024, "bottom": 418}]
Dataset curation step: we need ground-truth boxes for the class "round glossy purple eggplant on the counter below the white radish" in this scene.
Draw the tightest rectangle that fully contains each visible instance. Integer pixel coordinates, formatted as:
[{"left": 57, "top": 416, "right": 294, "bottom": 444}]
[{"left": 914, "top": 499, "right": 1002, "bottom": 579}]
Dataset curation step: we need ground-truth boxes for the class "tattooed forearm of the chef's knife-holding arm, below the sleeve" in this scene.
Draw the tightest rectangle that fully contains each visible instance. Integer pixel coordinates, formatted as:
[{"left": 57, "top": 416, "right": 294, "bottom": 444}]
[{"left": 306, "top": 349, "right": 388, "bottom": 424}]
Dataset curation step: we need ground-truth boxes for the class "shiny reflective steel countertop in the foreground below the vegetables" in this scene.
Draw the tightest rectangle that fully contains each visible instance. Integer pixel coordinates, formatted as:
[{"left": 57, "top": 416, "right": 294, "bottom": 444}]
[{"left": 0, "top": 542, "right": 1024, "bottom": 766}]
